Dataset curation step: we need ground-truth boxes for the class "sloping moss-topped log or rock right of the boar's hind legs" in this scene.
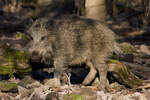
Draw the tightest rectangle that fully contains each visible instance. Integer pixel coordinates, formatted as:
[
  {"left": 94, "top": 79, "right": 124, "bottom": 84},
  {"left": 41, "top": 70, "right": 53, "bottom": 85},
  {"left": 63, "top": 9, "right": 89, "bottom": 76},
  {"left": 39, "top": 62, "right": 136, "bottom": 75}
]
[{"left": 107, "top": 60, "right": 143, "bottom": 88}]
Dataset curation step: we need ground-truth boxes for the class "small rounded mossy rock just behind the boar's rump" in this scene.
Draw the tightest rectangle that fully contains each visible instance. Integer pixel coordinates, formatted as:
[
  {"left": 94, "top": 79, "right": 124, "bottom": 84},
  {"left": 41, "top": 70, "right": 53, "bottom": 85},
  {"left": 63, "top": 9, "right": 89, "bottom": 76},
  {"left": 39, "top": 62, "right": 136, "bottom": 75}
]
[{"left": 119, "top": 43, "right": 135, "bottom": 54}]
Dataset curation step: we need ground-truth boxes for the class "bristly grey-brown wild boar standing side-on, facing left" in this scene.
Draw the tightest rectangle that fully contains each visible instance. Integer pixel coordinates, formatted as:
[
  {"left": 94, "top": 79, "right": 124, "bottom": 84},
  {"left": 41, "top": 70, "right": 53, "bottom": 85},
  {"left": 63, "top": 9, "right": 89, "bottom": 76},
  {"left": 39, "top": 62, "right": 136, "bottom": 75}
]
[{"left": 29, "top": 15, "right": 116, "bottom": 87}]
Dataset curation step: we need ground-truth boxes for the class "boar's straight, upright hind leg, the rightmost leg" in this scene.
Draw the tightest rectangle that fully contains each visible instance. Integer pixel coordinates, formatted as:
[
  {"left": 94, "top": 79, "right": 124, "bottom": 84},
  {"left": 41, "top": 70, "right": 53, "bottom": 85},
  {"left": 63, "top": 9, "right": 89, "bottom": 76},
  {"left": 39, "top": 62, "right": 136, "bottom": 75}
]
[{"left": 93, "top": 57, "right": 109, "bottom": 90}]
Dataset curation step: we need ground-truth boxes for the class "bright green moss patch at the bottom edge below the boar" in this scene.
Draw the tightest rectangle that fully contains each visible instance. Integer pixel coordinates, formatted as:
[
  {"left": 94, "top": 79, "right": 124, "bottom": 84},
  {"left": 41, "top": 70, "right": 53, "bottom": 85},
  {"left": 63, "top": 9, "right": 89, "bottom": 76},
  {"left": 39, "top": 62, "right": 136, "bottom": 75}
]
[{"left": 63, "top": 94, "right": 85, "bottom": 100}]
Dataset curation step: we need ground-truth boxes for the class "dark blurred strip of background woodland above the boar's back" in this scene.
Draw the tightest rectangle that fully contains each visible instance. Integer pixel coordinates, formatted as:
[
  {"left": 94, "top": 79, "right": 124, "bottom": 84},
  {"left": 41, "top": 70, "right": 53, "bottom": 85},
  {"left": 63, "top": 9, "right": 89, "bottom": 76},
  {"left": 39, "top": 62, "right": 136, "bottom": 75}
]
[{"left": 0, "top": 0, "right": 150, "bottom": 31}]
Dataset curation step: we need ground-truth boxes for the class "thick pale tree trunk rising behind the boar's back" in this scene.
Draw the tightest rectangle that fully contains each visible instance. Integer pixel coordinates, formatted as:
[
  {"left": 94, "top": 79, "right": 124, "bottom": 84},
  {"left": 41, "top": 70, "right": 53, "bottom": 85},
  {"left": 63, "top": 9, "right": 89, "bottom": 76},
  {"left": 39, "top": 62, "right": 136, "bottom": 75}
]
[{"left": 85, "top": 0, "right": 106, "bottom": 22}]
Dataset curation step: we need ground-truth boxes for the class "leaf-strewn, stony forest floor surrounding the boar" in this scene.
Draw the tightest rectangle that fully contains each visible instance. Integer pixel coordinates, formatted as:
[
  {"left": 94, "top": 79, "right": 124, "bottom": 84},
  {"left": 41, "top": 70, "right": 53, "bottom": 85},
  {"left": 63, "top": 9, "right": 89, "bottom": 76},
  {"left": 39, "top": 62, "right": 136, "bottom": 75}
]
[{"left": 0, "top": 2, "right": 150, "bottom": 100}]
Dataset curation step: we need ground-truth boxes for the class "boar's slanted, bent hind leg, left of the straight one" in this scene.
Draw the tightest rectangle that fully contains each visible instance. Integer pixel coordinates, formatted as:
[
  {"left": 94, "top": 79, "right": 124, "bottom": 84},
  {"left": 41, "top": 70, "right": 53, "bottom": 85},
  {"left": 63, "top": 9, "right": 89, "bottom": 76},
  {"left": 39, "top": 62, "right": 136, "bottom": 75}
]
[{"left": 82, "top": 61, "right": 97, "bottom": 85}]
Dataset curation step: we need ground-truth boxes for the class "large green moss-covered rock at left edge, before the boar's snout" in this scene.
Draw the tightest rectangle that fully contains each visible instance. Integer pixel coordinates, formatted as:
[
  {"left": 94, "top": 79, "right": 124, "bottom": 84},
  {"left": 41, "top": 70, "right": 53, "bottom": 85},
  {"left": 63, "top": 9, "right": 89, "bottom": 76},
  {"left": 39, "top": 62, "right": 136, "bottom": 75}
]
[{"left": 0, "top": 47, "right": 32, "bottom": 76}]
